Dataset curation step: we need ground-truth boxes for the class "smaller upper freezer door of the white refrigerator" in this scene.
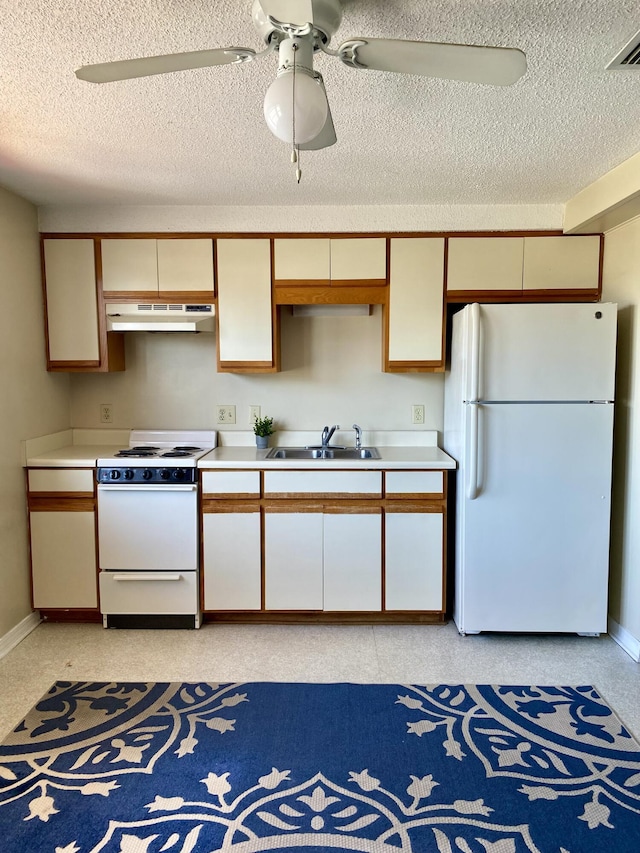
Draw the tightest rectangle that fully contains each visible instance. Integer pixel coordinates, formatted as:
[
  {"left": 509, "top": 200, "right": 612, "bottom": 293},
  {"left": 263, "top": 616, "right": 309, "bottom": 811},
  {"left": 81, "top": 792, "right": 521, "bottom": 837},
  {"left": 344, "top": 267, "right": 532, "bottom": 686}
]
[{"left": 468, "top": 303, "right": 617, "bottom": 401}]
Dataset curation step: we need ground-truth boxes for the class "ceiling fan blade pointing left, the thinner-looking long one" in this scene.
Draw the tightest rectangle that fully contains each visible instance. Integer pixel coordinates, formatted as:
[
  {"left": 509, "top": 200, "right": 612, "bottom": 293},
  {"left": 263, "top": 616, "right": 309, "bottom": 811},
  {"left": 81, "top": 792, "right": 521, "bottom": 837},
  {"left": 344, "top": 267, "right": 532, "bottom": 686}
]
[{"left": 76, "top": 47, "right": 256, "bottom": 83}]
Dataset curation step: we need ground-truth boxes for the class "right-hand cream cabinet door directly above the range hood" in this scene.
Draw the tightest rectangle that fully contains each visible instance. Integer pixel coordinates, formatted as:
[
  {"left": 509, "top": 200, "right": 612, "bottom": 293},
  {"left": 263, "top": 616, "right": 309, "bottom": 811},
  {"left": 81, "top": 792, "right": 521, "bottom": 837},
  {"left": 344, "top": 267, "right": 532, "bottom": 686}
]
[{"left": 157, "top": 238, "right": 213, "bottom": 296}]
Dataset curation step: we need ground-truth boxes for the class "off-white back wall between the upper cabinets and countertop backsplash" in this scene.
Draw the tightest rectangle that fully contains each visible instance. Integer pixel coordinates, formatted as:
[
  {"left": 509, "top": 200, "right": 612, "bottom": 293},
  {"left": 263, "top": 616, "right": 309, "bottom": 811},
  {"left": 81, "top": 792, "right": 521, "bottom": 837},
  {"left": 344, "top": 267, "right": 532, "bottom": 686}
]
[{"left": 71, "top": 307, "right": 443, "bottom": 435}]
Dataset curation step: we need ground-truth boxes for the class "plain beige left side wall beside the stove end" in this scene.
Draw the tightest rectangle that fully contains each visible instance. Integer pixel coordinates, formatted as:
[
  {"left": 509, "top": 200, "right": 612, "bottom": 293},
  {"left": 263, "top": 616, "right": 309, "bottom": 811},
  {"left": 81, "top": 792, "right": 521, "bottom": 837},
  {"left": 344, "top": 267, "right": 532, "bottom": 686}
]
[{"left": 0, "top": 188, "right": 70, "bottom": 639}]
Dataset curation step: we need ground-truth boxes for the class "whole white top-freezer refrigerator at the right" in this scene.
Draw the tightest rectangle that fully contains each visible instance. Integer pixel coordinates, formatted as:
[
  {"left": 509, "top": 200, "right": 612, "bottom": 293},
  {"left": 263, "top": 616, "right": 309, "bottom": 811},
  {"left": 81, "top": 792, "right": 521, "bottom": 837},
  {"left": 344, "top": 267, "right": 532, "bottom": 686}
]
[{"left": 444, "top": 303, "right": 617, "bottom": 636}]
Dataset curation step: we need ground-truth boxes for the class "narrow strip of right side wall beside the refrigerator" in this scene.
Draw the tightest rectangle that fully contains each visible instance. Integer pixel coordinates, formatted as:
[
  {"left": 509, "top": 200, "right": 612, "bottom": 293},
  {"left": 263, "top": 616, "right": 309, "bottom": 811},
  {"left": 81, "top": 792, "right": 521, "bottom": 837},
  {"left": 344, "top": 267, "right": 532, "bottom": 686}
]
[{"left": 602, "top": 219, "right": 640, "bottom": 645}]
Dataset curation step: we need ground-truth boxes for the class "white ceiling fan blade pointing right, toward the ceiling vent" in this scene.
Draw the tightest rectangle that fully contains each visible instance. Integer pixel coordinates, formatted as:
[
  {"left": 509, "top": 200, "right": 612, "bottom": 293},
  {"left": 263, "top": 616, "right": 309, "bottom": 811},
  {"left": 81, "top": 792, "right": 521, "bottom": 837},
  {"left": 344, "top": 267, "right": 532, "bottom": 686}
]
[{"left": 338, "top": 38, "right": 527, "bottom": 86}]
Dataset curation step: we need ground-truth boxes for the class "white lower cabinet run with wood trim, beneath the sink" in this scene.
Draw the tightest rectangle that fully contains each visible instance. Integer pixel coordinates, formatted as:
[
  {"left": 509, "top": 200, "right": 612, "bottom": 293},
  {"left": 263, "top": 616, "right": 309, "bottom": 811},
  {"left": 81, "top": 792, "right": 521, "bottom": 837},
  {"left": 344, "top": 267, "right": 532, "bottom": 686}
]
[{"left": 202, "top": 468, "right": 446, "bottom": 621}]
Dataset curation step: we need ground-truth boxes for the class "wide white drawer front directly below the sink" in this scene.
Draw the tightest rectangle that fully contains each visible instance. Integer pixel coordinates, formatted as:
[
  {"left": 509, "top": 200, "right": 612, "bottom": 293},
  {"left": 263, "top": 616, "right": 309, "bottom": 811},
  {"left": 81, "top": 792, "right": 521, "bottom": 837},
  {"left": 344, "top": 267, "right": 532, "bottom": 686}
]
[{"left": 264, "top": 471, "right": 382, "bottom": 497}]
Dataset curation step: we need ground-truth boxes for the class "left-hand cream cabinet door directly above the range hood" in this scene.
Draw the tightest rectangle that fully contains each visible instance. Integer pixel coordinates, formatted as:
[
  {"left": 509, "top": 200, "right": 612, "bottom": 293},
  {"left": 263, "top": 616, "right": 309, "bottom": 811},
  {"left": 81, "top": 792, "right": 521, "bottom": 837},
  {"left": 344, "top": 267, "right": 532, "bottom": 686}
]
[{"left": 101, "top": 239, "right": 158, "bottom": 294}]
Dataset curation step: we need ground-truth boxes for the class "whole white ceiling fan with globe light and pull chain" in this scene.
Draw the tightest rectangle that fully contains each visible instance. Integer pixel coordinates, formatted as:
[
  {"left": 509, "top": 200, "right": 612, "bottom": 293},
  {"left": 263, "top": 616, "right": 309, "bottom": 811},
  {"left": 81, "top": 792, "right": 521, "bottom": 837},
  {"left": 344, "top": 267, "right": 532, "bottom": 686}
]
[{"left": 75, "top": 0, "right": 527, "bottom": 181}]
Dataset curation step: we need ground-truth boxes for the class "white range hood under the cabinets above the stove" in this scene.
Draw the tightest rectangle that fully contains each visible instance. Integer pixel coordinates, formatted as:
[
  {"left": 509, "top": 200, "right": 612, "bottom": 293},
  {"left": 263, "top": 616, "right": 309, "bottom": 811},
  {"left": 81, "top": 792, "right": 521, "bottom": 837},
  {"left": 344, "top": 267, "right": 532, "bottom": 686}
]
[{"left": 105, "top": 302, "right": 215, "bottom": 332}]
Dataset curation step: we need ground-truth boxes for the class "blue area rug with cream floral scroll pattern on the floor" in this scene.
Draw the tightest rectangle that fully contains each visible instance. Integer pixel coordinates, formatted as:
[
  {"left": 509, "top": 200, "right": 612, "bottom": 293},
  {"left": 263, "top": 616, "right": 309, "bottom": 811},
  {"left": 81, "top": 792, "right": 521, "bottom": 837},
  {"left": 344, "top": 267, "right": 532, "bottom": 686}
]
[{"left": 0, "top": 681, "right": 640, "bottom": 853}]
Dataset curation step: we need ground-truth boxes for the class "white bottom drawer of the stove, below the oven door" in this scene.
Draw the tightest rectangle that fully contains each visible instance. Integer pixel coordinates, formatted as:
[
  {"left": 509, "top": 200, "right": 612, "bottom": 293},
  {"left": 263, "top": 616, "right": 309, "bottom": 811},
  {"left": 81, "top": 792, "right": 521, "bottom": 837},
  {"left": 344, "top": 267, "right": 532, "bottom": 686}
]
[{"left": 100, "top": 571, "right": 198, "bottom": 616}]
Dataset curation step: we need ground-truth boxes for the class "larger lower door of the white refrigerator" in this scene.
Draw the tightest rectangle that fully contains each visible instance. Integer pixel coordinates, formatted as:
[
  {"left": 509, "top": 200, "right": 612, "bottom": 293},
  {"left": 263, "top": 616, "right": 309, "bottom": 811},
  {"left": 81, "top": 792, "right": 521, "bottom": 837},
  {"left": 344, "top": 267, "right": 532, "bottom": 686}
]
[{"left": 454, "top": 403, "right": 613, "bottom": 633}]
